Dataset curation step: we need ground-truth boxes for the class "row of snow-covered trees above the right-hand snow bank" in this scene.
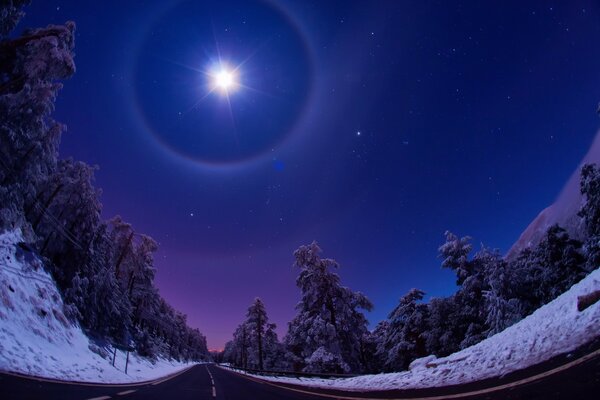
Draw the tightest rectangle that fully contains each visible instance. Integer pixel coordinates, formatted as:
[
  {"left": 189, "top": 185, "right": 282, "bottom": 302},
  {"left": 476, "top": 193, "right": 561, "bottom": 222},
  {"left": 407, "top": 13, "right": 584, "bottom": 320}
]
[{"left": 222, "top": 164, "right": 600, "bottom": 373}]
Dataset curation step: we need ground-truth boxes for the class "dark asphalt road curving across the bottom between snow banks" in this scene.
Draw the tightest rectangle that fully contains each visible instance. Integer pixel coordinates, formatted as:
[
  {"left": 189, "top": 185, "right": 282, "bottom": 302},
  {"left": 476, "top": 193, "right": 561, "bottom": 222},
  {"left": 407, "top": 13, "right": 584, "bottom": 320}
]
[{"left": 0, "top": 353, "right": 600, "bottom": 400}]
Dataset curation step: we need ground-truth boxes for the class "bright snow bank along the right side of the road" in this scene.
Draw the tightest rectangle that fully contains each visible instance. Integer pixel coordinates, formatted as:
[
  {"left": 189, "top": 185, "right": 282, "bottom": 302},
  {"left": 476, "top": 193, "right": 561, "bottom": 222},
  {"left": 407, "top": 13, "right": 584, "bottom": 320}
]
[{"left": 244, "top": 269, "right": 600, "bottom": 390}]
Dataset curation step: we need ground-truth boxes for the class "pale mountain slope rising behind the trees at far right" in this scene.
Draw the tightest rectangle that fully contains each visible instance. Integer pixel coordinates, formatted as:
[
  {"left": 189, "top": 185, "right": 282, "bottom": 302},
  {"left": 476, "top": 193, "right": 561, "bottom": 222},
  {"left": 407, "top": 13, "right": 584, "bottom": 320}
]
[{"left": 506, "top": 132, "right": 600, "bottom": 258}]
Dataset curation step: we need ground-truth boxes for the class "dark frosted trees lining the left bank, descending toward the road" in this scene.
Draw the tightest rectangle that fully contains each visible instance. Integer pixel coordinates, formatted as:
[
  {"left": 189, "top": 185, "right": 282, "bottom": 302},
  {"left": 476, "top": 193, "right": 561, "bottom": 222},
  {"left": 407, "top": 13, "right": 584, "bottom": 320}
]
[{"left": 0, "top": 0, "right": 208, "bottom": 360}]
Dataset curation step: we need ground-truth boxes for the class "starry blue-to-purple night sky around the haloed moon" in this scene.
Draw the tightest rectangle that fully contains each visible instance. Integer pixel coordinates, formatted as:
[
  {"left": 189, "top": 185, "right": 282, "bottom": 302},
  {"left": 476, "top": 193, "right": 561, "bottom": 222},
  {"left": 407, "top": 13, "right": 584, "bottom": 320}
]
[{"left": 19, "top": 0, "right": 600, "bottom": 349}]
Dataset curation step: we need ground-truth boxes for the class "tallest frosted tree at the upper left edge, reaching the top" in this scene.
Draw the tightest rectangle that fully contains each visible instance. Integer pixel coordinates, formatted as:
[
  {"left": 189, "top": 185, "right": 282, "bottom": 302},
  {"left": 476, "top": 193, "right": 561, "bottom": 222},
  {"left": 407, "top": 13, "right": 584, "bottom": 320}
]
[{"left": 0, "top": 11, "right": 75, "bottom": 235}]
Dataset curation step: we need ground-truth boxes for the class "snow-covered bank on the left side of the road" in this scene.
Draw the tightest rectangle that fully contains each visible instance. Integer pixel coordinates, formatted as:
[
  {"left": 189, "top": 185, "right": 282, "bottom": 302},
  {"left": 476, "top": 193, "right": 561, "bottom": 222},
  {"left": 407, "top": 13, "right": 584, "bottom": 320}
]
[{"left": 0, "top": 232, "right": 191, "bottom": 383}]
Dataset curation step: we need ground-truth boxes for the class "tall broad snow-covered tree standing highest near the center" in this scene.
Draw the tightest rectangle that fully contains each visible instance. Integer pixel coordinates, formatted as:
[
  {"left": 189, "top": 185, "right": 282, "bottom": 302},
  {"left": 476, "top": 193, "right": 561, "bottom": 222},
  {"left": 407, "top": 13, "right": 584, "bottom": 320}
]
[{"left": 284, "top": 242, "right": 372, "bottom": 372}]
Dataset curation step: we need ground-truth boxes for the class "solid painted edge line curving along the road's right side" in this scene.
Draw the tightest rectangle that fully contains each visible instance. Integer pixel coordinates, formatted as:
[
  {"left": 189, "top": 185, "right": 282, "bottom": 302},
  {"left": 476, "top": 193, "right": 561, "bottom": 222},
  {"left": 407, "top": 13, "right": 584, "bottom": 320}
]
[{"left": 219, "top": 349, "right": 600, "bottom": 400}]
